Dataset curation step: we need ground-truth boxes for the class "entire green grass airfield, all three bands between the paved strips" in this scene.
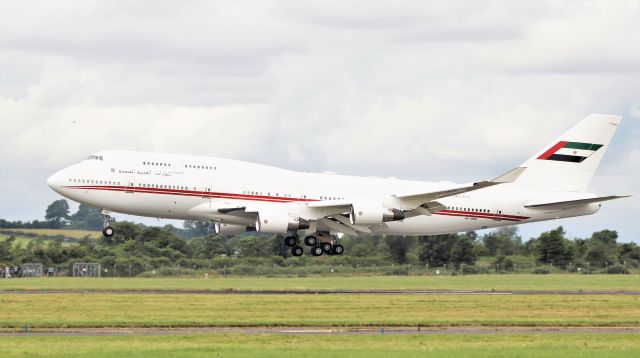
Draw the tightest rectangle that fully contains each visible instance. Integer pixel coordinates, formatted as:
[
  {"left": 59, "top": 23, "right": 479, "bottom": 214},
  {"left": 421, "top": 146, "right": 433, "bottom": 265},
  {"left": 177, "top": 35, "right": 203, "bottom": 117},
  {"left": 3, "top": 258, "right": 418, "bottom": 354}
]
[{"left": 0, "top": 275, "right": 640, "bottom": 358}]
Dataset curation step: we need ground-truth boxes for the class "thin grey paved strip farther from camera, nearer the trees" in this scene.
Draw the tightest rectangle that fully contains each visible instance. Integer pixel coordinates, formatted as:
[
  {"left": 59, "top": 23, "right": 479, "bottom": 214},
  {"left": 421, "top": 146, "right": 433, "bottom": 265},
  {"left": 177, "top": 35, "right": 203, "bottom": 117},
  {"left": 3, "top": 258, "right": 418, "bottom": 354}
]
[{"left": 0, "top": 289, "right": 640, "bottom": 295}]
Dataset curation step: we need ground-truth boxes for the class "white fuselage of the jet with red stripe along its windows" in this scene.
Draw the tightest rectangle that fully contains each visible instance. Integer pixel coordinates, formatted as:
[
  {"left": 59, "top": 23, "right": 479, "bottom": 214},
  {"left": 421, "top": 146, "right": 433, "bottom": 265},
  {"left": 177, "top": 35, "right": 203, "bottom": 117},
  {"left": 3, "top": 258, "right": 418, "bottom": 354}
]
[{"left": 48, "top": 151, "right": 600, "bottom": 235}]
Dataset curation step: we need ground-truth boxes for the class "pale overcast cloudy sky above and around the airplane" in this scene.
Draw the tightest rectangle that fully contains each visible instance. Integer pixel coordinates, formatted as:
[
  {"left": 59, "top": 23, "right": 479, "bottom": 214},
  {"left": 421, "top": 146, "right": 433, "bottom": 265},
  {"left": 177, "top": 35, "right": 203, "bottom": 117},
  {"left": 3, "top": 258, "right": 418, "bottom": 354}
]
[{"left": 0, "top": 0, "right": 640, "bottom": 242}]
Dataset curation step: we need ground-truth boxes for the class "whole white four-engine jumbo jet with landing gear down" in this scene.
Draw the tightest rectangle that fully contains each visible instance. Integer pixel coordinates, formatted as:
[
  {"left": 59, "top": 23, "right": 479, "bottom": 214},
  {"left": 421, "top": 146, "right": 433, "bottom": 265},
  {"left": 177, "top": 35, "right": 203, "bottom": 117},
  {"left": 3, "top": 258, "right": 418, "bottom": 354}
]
[{"left": 47, "top": 114, "right": 622, "bottom": 256}]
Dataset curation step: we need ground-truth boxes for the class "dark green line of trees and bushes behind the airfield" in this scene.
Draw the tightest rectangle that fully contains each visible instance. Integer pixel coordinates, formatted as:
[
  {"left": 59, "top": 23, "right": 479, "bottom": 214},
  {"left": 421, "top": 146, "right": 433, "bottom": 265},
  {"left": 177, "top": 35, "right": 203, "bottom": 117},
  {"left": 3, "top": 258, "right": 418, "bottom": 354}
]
[{"left": 0, "top": 200, "right": 640, "bottom": 275}]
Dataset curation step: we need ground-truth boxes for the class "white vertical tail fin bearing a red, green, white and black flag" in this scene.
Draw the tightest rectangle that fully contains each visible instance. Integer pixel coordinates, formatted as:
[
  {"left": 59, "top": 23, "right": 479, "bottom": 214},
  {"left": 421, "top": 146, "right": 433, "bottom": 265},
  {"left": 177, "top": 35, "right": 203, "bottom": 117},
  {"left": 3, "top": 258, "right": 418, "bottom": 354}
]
[{"left": 514, "top": 114, "right": 622, "bottom": 192}]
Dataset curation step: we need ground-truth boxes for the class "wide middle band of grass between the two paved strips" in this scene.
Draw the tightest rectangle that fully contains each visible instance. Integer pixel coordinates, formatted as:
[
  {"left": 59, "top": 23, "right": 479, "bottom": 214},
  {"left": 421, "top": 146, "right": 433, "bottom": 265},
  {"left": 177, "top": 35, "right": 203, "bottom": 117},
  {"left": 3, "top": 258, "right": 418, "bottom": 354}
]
[{"left": 0, "top": 293, "right": 640, "bottom": 328}]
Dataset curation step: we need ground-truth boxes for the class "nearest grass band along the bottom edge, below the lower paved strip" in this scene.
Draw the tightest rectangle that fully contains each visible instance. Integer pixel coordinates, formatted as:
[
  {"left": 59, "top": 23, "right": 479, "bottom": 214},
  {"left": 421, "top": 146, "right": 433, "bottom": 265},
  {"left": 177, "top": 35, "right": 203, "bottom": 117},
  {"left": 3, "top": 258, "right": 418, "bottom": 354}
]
[{"left": 0, "top": 334, "right": 640, "bottom": 358}]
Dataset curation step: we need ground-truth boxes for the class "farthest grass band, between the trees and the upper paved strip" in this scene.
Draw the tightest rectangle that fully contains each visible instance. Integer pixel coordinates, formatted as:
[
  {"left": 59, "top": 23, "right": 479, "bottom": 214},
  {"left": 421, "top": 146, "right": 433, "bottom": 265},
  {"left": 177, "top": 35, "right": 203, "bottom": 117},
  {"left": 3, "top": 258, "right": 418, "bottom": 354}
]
[{"left": 0, "top": 274, "right": 640, "bottom": 292}]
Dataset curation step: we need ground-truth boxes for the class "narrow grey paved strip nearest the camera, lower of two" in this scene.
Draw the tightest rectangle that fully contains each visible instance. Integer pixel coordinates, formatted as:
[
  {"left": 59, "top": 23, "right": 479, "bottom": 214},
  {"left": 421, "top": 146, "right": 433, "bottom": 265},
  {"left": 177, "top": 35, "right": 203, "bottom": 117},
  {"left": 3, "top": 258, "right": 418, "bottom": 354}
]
[{"left": 0, "top": 326, "right": 640, "bottom": 337}]
